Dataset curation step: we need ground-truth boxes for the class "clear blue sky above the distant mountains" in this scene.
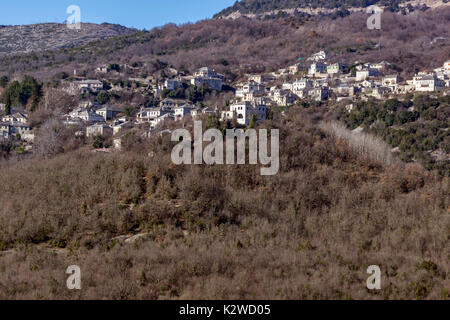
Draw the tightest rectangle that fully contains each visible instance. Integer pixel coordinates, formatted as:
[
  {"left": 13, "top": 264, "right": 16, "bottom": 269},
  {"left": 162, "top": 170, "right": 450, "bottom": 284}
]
[{"left": 0, "top": 0, "right": 235, "bottom": 29}]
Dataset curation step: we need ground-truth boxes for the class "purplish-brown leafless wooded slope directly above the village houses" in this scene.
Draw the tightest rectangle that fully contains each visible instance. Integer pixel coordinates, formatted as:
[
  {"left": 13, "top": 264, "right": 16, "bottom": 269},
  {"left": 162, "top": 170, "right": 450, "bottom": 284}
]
[{"left": 0, "top": 7, "right": 450, "bottom": 79}]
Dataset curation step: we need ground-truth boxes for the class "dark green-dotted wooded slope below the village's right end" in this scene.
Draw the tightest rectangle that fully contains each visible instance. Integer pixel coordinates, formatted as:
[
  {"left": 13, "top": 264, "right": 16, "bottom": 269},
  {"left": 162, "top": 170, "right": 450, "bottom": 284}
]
[{"left": 339, "top": 95, "right": 450, "bottom": 176}]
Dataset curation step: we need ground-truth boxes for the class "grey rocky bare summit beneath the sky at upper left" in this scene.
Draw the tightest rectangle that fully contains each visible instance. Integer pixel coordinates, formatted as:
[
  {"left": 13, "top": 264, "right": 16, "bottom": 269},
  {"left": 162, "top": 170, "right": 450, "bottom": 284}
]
[{"left": 0, "top": 23, "right": 137, "bottom": 55}]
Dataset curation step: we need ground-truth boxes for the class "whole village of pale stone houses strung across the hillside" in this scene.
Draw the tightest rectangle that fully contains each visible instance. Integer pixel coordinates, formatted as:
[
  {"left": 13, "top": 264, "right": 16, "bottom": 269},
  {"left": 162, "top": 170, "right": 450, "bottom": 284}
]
[{"left": 0, "top": 51, "right": 450, "bottom": 150}]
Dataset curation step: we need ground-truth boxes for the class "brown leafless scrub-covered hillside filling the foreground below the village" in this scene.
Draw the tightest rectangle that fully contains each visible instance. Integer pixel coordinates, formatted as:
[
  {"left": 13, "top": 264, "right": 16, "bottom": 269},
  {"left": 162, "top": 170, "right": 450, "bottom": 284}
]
[{"left": 0, "top": 108, "right": 450, "bottom": 299}]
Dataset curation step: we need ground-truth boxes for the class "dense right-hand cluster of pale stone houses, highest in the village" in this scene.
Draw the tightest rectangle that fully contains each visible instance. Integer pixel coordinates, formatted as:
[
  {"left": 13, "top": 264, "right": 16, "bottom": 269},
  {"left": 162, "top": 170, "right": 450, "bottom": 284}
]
[{"left": 236, "top": 51, "right": 450, "bottom": 111}]
